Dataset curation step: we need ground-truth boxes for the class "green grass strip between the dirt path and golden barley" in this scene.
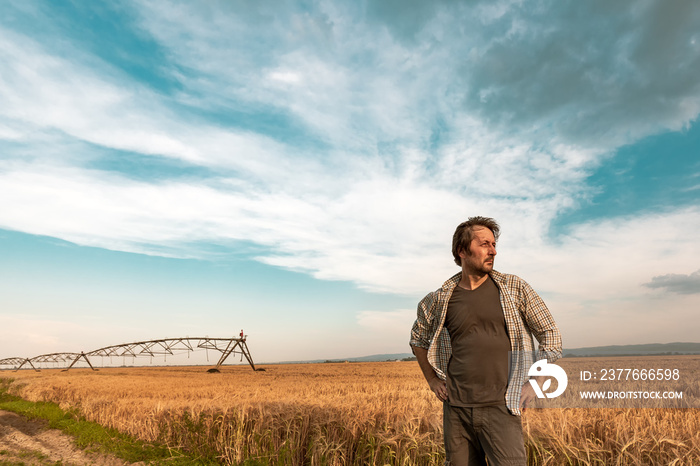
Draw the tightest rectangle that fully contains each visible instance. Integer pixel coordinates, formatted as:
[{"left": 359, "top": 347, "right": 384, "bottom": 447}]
[{"left": 0, "top": 377, "right": 219, "bottom": 466}]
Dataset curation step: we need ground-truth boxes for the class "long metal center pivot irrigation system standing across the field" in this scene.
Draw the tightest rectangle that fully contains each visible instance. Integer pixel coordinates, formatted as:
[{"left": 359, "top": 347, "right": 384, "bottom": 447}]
[{"left": 0, "top": 332, "right": 264, "bottom": 372}]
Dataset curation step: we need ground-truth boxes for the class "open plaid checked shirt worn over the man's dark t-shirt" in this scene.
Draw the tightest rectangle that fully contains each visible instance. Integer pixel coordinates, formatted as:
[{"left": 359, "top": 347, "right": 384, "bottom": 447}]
[{"left": 410, "top": 270, "right": 562, "bottom": 415}]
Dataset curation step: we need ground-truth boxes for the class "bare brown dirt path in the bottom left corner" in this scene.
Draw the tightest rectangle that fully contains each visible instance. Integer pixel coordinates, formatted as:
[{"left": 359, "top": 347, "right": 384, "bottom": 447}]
[{"left": 0, "top": 411, "right": 138, "bottom": 466}]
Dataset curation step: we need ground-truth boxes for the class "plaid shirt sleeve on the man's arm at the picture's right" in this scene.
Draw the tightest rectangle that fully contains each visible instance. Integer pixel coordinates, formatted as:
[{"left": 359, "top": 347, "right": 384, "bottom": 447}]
[{"left": 521, "top": 282, "right": 562, "bottom": 362}]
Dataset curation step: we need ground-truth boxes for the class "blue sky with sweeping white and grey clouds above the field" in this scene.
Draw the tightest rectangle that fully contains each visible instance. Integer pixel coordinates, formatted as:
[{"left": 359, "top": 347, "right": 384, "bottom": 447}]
[{"left": 0, "top": 0, "right": 700, "bottom": 361}]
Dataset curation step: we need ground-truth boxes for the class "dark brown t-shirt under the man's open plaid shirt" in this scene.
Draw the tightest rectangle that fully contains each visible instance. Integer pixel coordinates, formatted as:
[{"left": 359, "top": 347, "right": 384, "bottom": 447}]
[{"left": 445, "top": 277, "right": 510, "bottom": 407}]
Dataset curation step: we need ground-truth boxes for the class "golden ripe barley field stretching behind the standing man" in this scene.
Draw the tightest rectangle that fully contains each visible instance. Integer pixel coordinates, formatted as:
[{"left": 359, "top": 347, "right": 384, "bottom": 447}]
[{"left": 0, "top": 356, "right": 700, "bottom": 466}]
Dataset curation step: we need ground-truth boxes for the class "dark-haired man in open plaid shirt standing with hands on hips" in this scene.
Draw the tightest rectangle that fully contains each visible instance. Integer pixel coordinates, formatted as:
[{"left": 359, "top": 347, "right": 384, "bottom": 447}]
[{"left": 410, "top": 217, "right": 561, "bottom": 466}]
